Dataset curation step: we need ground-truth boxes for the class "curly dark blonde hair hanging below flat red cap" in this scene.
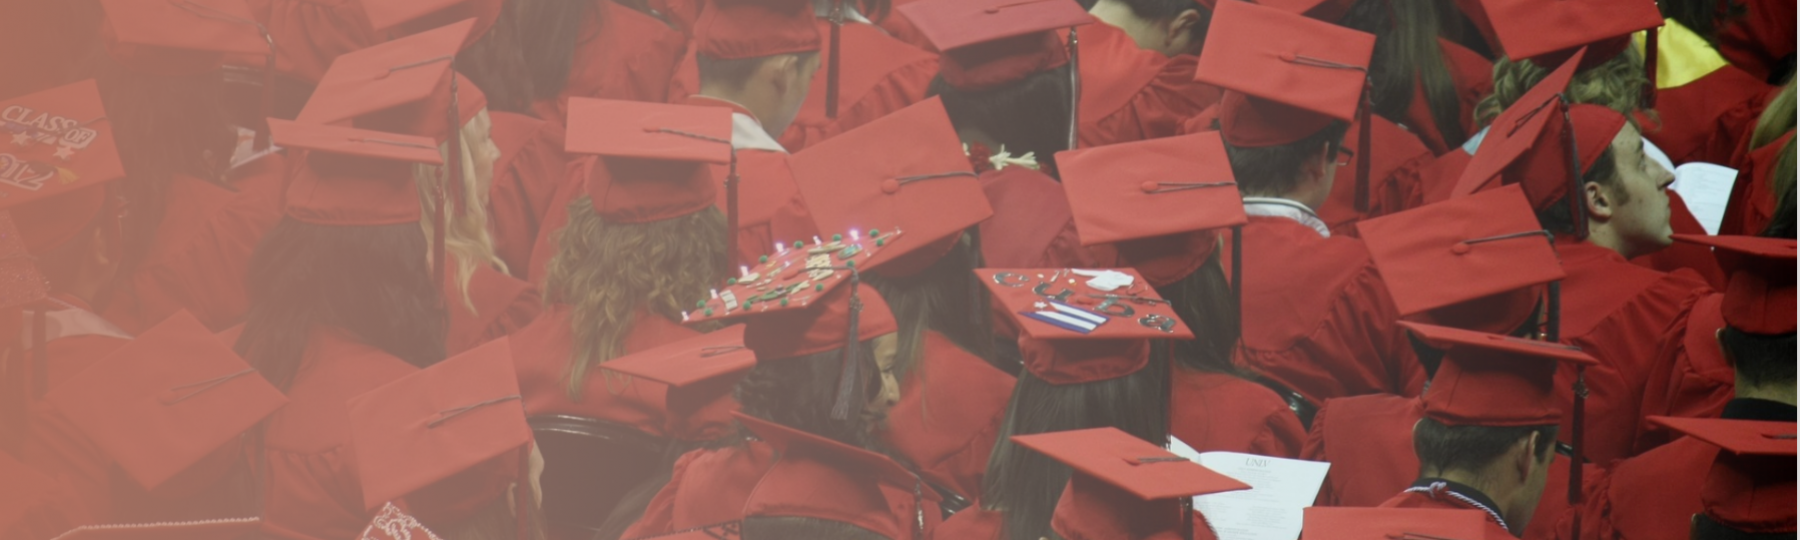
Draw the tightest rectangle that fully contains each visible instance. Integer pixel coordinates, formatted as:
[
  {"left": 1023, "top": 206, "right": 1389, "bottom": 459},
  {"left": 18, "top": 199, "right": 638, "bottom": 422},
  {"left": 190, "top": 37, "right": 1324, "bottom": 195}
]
[{"left": 544, "top": 196, "right": 725, "bottom": 400}]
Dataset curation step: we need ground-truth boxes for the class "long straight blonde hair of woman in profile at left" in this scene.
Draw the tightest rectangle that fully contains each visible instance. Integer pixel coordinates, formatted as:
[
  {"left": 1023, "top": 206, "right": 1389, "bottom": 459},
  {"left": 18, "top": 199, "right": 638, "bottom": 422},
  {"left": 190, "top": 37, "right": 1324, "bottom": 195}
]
[{"left": 412, "top": 110, "right": 506, "bottom": 313}]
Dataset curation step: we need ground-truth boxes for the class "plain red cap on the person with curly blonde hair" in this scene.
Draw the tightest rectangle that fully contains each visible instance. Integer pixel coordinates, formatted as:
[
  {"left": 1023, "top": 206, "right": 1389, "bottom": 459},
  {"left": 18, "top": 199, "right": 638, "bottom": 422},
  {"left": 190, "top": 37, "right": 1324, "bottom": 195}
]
[{"left": 563, "top": 97, "right": 731, "bottom": 223}]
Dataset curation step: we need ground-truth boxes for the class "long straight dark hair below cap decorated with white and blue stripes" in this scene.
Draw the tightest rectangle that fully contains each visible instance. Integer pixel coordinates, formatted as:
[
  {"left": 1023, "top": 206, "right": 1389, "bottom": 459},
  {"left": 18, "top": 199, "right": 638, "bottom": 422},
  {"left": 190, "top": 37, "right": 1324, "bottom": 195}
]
[{"left": 981, "top": 342, "right": 1168, "bottom": 540}]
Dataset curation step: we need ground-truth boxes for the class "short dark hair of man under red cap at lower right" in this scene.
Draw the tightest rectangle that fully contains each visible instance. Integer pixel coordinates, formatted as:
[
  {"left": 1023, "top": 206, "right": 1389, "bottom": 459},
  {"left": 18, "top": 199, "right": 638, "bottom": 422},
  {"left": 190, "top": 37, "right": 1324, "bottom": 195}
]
[{"left": 1413, "top": 418, "right": 1557, "bottom": 470}]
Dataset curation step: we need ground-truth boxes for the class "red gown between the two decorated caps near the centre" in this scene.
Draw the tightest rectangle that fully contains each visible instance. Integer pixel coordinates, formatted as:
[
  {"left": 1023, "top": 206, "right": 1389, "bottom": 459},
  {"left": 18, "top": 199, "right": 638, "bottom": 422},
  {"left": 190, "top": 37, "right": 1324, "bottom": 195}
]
[{"left": 882, "top": 331, "right": 1015, "bottom": 500}]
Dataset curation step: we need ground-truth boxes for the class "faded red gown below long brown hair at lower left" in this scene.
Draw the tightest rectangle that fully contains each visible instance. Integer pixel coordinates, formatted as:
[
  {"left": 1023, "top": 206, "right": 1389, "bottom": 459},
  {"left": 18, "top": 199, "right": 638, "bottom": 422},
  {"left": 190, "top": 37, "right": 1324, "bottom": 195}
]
[{"left": 263, "top": 329, "right": 419, "bottom": 540}]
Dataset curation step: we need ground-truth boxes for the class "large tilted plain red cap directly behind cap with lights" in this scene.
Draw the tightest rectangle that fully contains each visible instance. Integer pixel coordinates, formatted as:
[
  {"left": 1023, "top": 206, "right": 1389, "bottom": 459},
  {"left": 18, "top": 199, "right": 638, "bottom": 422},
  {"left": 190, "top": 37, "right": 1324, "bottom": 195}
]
[{"left": 792, "top": 97, "right": 994, "bottom": 275}]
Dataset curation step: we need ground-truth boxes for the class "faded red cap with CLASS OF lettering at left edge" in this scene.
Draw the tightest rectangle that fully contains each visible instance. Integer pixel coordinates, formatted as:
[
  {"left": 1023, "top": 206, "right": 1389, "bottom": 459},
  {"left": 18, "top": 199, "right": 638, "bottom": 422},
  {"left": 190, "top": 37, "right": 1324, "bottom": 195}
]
[{"left": 0, "top": 79, "right": 124, "bottom": 254}]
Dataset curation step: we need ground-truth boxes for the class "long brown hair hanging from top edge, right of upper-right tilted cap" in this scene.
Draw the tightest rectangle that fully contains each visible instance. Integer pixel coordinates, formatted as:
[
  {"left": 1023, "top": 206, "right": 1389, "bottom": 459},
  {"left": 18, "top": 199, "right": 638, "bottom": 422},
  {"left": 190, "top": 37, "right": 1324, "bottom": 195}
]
[{"left": 1343, "top": 0, "right": 1469, "bottom": 148}]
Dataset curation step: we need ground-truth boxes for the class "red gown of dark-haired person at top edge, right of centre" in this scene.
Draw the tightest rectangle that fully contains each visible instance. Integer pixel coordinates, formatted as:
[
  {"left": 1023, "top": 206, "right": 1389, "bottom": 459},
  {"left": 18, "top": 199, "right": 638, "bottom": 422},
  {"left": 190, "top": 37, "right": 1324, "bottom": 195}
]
[{"left": 1062, "top": 23, "right": 1222, "bottom": 148}]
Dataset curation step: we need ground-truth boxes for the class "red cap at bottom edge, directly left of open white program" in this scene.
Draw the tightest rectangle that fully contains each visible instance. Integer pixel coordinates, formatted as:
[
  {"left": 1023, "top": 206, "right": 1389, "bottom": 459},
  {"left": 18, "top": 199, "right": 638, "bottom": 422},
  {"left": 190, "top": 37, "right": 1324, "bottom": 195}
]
[{"left": 1012, "top": 427, "right": 1249, "bottom": 540}]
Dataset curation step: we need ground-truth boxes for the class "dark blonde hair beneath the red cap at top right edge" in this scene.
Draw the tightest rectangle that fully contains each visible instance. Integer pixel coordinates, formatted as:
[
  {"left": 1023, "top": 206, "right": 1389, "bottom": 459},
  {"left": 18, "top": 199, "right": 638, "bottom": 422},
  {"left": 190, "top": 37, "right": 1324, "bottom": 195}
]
[{"left": 1474, "top": 49, "right": 1649, "bottom": 126}]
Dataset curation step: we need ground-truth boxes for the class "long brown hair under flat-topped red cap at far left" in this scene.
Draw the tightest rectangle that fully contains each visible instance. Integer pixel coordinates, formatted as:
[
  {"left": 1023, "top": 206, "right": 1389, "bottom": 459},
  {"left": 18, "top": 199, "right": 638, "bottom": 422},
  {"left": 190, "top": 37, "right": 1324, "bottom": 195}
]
[{"left": 238, "top": 218, "right": 446, "bottom": 389}]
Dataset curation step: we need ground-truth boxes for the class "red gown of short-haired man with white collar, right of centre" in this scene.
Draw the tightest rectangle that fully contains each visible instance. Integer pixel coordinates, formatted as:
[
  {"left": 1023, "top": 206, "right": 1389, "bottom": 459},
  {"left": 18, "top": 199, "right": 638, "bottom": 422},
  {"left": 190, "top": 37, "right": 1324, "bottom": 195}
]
[{"left": 1235, "top": 216, "right": 1426, "bottom": 405}]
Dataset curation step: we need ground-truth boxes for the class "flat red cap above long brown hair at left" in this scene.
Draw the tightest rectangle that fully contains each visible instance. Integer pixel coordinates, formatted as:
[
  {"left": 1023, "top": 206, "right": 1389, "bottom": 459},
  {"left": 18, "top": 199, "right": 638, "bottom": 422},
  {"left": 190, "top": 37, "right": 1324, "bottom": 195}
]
[{"left": 268, "top": 119, "right": 443, "bottom": 225}]
